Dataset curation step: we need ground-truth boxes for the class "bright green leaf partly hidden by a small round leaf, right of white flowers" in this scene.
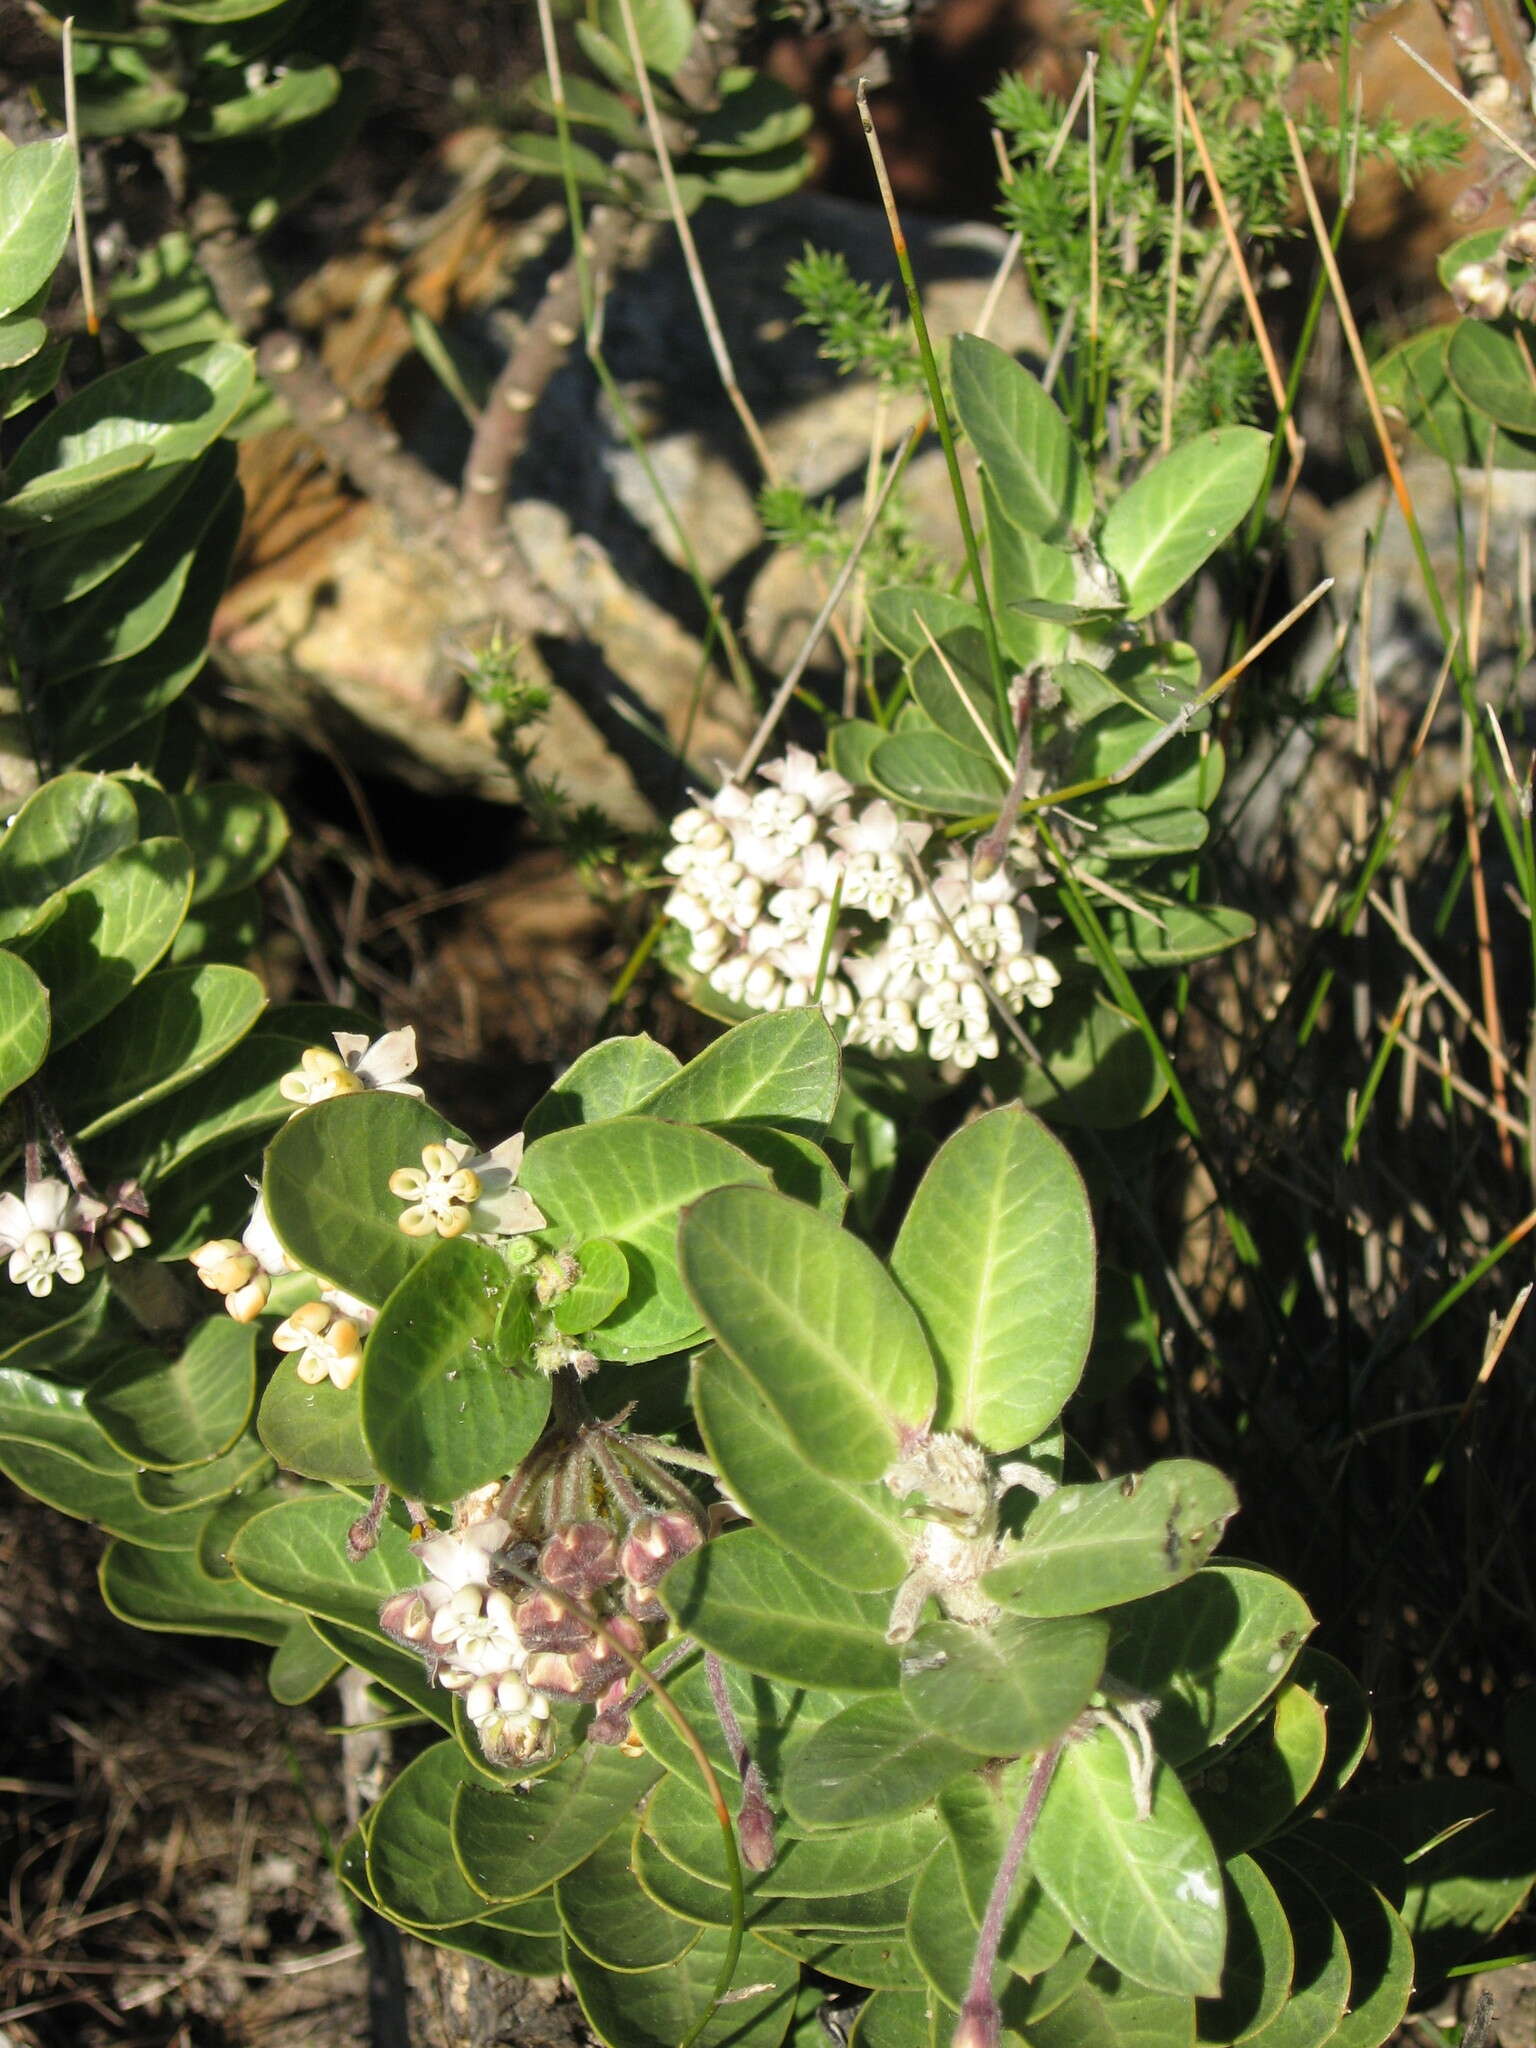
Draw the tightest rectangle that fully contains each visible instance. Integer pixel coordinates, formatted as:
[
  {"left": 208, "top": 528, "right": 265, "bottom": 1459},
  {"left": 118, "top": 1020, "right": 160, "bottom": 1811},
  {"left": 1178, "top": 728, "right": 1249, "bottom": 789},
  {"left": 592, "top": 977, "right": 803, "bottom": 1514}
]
[{"left": 522, "top": 1116, "right": 768, "bottom": 1360}]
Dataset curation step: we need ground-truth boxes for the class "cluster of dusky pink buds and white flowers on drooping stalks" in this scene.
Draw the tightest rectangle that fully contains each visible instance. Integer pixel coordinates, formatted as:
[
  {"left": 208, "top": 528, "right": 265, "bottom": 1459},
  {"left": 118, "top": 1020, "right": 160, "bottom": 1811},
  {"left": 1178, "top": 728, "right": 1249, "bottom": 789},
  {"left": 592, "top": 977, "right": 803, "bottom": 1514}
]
[{"left": 379, "top": 1438, "right": 702, "bottom": 1765}]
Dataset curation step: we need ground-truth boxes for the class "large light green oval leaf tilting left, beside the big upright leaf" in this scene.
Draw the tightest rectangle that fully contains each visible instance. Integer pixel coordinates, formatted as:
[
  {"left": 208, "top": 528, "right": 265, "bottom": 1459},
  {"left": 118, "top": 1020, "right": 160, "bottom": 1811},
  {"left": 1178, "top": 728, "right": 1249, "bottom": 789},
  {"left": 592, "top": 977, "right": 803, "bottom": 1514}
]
[{"left": 680, "top": 1188, "right": 934, "bottom": 1481}]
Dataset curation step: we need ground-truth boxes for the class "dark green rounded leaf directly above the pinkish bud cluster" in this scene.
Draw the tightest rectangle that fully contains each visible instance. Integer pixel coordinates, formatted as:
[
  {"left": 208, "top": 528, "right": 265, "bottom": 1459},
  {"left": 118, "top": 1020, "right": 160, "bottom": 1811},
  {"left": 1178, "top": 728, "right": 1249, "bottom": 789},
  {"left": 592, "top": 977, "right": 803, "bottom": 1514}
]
[{"left": 360, "top": 1237, "right": 549, "bottom": 1505}]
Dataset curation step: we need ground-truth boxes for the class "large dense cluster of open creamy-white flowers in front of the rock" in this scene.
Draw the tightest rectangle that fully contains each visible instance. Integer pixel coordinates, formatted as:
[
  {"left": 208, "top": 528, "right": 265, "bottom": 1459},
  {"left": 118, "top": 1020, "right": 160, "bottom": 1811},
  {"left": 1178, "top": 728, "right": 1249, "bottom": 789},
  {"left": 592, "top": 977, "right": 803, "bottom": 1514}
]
[{"left": 662, "top": 748, "right": 1061, "bottom": 1067}]
